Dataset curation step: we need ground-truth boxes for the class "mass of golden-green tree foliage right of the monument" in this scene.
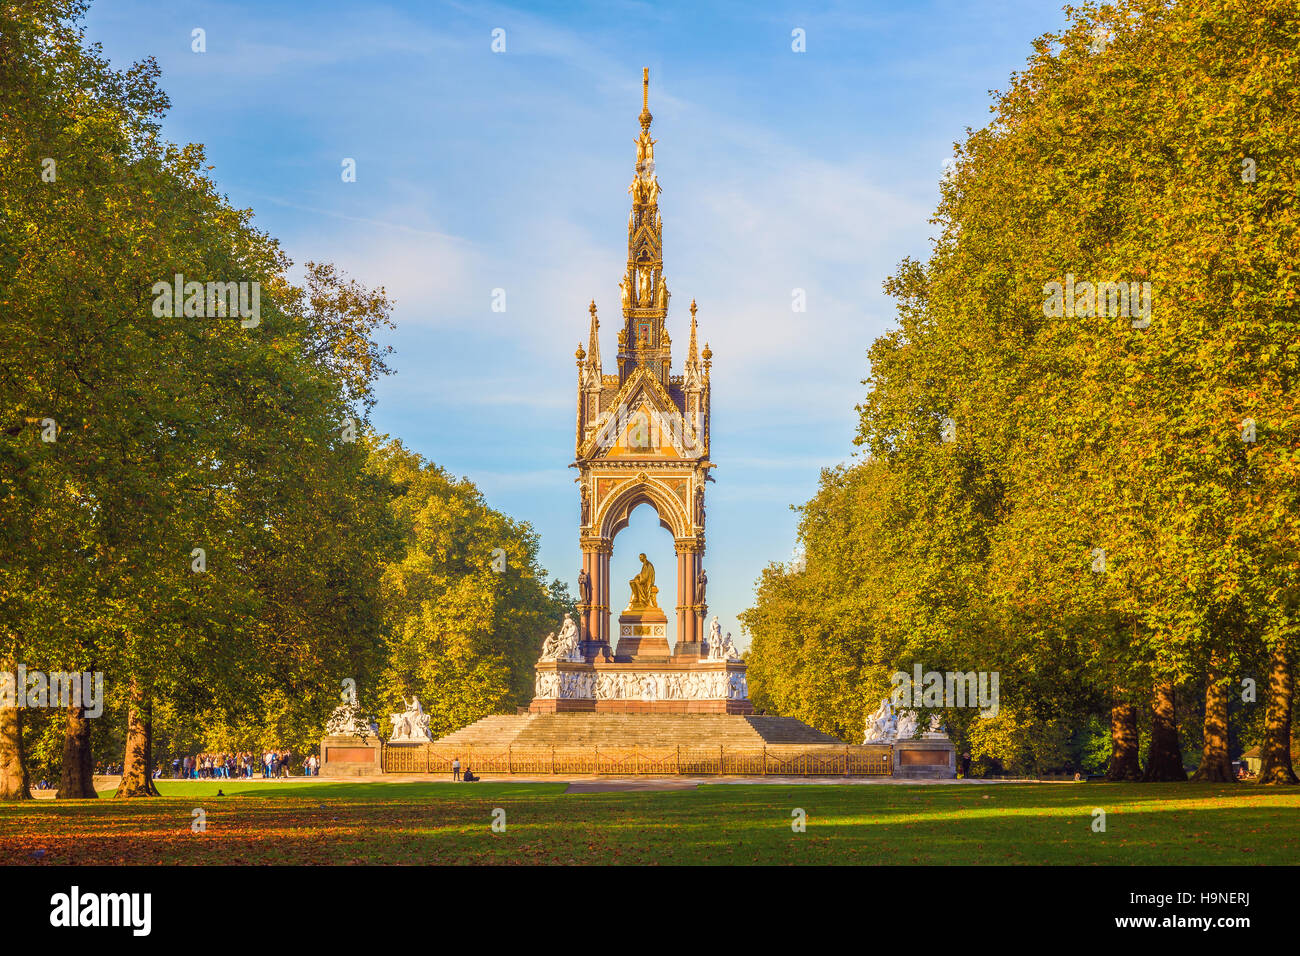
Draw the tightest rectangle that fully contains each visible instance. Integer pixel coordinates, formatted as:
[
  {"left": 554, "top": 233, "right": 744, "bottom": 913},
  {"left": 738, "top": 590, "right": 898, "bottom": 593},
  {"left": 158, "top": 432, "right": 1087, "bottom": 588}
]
[{"left": 746, "top": 0, "right": 1300, "bottom": 782}]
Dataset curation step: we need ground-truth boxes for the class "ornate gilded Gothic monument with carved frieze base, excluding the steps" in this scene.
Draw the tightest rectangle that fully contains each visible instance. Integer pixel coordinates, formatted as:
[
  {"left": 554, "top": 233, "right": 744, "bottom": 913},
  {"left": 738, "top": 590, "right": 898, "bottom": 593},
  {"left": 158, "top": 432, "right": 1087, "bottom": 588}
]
[{"left": 530, "top": 70, "right": 753, "bottom": 714}]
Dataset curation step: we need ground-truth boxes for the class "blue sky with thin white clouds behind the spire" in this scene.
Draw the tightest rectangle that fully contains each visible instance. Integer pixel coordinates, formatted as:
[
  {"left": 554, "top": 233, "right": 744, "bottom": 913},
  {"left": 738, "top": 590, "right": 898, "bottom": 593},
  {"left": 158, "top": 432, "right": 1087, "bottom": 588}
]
[{"left": 87, "top": 0, "right": 1063, "bottom": 646}]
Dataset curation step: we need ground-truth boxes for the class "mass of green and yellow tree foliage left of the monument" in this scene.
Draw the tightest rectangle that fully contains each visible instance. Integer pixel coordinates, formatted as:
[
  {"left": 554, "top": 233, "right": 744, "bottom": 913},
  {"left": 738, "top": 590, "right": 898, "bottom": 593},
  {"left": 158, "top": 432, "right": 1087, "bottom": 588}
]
[{"left": 0, "top": 0, "right": 563, "bottom": 799}]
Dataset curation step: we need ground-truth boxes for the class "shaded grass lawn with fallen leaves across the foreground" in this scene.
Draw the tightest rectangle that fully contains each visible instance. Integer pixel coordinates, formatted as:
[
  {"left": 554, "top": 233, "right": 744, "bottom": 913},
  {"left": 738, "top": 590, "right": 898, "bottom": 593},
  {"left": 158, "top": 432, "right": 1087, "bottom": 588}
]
[{"left": 0, "top": 780, "right": 1300, "bottom": 865}]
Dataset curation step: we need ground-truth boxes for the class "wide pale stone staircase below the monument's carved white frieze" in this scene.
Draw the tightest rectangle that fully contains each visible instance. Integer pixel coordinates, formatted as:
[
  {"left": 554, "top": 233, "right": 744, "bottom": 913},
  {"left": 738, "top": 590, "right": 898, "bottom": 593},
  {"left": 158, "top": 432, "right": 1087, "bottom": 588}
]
[{"left": 437, "top": 713, "right": 844, "bottom": 750}]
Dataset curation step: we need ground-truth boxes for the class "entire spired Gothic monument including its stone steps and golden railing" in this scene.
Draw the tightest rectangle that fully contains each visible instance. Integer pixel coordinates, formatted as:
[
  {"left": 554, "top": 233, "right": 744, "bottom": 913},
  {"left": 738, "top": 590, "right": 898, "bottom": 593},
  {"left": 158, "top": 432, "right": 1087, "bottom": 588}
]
[{"left": 325, "top": 72, "right": 892, "bottom": 775}]
